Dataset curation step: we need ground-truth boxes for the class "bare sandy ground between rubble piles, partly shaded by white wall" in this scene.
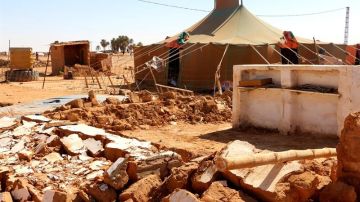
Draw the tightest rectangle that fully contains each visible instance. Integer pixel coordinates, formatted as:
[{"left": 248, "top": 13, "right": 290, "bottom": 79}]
[{"left": 122, "top": 123, "right": 338, "bottom": 156}]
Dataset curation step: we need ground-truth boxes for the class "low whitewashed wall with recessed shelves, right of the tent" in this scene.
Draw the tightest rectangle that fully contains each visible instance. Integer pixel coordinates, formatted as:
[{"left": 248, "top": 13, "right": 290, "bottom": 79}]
[{"left": 233, "top": 65, "right": 360, "bottom": 135}]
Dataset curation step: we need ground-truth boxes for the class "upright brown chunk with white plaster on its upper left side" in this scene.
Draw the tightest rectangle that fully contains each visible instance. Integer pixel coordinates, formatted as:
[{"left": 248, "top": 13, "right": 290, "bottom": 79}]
[{"left": 104, "top": 158, "right": 129, "bottom": 190}]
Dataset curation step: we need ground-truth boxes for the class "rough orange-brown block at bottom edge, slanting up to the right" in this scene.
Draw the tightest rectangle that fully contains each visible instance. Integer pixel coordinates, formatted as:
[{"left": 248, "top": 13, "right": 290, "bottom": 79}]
[{"left": 119, "top": 175, "right": 161, "bottom": 202}]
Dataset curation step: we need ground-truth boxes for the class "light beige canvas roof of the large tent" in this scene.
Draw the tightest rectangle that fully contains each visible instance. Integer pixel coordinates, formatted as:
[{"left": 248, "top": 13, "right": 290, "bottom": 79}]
[{"left": 163, "top": 6, "right": 313, "bottom": 45}]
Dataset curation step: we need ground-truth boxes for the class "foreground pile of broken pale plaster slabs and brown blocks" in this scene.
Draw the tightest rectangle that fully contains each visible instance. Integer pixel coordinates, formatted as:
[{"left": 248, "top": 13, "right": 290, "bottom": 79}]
[{"left": 0, "top": 115, "right": 336, "bottom": 202}]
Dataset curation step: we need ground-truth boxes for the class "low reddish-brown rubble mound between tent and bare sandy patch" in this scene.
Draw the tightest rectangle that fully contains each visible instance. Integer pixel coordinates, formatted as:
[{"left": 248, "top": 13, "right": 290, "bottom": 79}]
[{"left": 44, "top": 91, "right": 231, "bottom": 131}]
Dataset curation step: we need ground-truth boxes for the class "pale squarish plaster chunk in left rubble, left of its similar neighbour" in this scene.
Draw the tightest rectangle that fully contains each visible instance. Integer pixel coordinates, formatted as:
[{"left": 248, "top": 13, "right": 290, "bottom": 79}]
[{"left": 60, "top": 134, "right": 86, "bottom": 156}]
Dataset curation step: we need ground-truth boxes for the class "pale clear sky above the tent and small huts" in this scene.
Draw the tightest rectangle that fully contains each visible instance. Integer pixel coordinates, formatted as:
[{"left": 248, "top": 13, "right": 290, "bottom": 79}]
[{"left": 0, "top": 0, "right": 360, "bottom": 51}]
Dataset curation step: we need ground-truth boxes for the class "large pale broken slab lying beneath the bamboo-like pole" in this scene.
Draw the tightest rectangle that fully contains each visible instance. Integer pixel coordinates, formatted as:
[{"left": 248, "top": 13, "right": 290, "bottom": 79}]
[{"left": 219, "top": 141, "right": 304, "bottom": 201}]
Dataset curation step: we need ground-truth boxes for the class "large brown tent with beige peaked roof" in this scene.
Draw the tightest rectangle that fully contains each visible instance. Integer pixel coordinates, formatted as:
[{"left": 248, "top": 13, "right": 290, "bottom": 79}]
[{"left": 134, "top": 0, "right": 346, "bottom": 90}]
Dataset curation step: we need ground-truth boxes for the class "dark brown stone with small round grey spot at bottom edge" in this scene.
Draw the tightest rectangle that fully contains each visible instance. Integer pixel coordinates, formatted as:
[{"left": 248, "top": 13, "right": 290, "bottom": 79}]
[{"left": 86, "top": 183, "right": 117, "bottom": 202}]
